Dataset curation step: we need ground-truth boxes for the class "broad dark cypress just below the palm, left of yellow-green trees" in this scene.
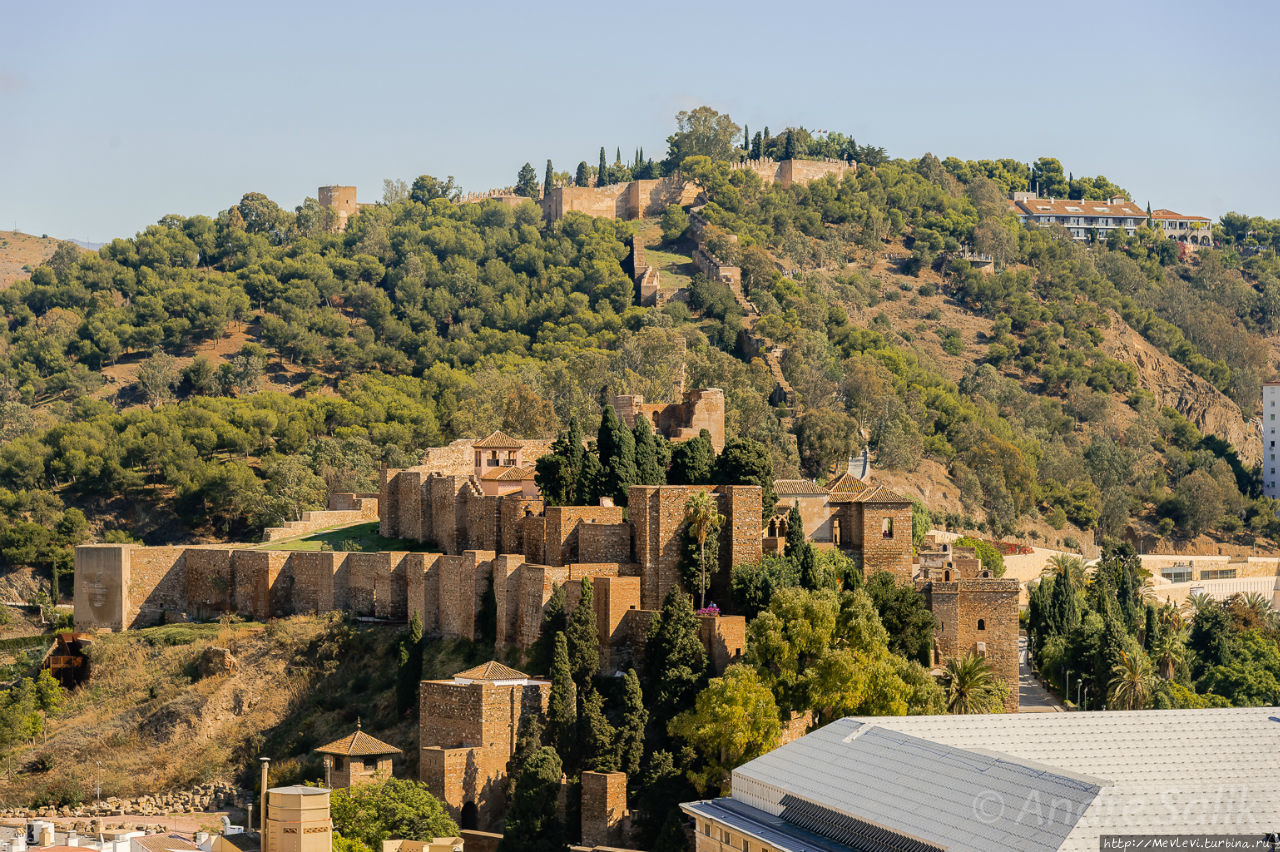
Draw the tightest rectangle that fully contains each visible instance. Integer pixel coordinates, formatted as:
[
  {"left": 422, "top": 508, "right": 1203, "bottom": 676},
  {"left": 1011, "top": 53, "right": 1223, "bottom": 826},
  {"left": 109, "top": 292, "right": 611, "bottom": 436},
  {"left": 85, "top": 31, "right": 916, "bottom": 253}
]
[{"left": 644, "top": 586, "right": 708, "bottom": 719}]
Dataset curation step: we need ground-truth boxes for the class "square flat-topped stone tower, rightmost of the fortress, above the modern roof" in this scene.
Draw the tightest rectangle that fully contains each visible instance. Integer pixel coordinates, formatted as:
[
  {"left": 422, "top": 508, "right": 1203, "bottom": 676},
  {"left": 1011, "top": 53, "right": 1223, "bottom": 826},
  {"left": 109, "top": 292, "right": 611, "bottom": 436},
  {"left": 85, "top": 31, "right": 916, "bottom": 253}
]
[{"left": 928, "top": 578, "right": 1019, "bottom": 713}]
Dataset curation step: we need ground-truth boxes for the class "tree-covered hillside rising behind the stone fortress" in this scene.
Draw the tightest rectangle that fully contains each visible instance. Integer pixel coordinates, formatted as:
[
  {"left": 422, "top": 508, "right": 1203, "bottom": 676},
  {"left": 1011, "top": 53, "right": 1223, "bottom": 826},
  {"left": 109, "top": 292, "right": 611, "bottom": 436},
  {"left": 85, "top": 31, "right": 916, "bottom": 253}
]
[{"left": 0, "top": 107, "right": 1280, "bottom": 591}]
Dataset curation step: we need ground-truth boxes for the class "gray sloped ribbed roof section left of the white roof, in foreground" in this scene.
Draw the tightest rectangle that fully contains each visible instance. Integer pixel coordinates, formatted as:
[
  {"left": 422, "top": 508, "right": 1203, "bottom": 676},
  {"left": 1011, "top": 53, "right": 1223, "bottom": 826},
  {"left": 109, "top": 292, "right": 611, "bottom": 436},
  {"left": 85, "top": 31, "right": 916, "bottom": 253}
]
[{"left": 733, "top": 719, "right": 1100, "bottom": 852}]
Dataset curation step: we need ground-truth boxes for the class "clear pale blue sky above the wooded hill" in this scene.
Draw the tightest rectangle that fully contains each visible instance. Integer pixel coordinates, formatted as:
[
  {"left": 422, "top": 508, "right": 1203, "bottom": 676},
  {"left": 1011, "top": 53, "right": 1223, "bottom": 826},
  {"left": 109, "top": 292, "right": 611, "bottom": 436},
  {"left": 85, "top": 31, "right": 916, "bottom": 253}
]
[{"left": 0, "top": 0, "right": 1280, "bottom": 242}]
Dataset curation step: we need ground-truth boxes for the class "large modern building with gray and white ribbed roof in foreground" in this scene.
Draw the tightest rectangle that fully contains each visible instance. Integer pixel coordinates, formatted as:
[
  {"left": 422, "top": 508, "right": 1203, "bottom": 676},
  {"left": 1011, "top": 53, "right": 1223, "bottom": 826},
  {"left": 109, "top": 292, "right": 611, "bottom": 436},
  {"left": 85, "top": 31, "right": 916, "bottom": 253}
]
[{"left": 681, "top": 707, "right": 1280, "bottom": 852}]
